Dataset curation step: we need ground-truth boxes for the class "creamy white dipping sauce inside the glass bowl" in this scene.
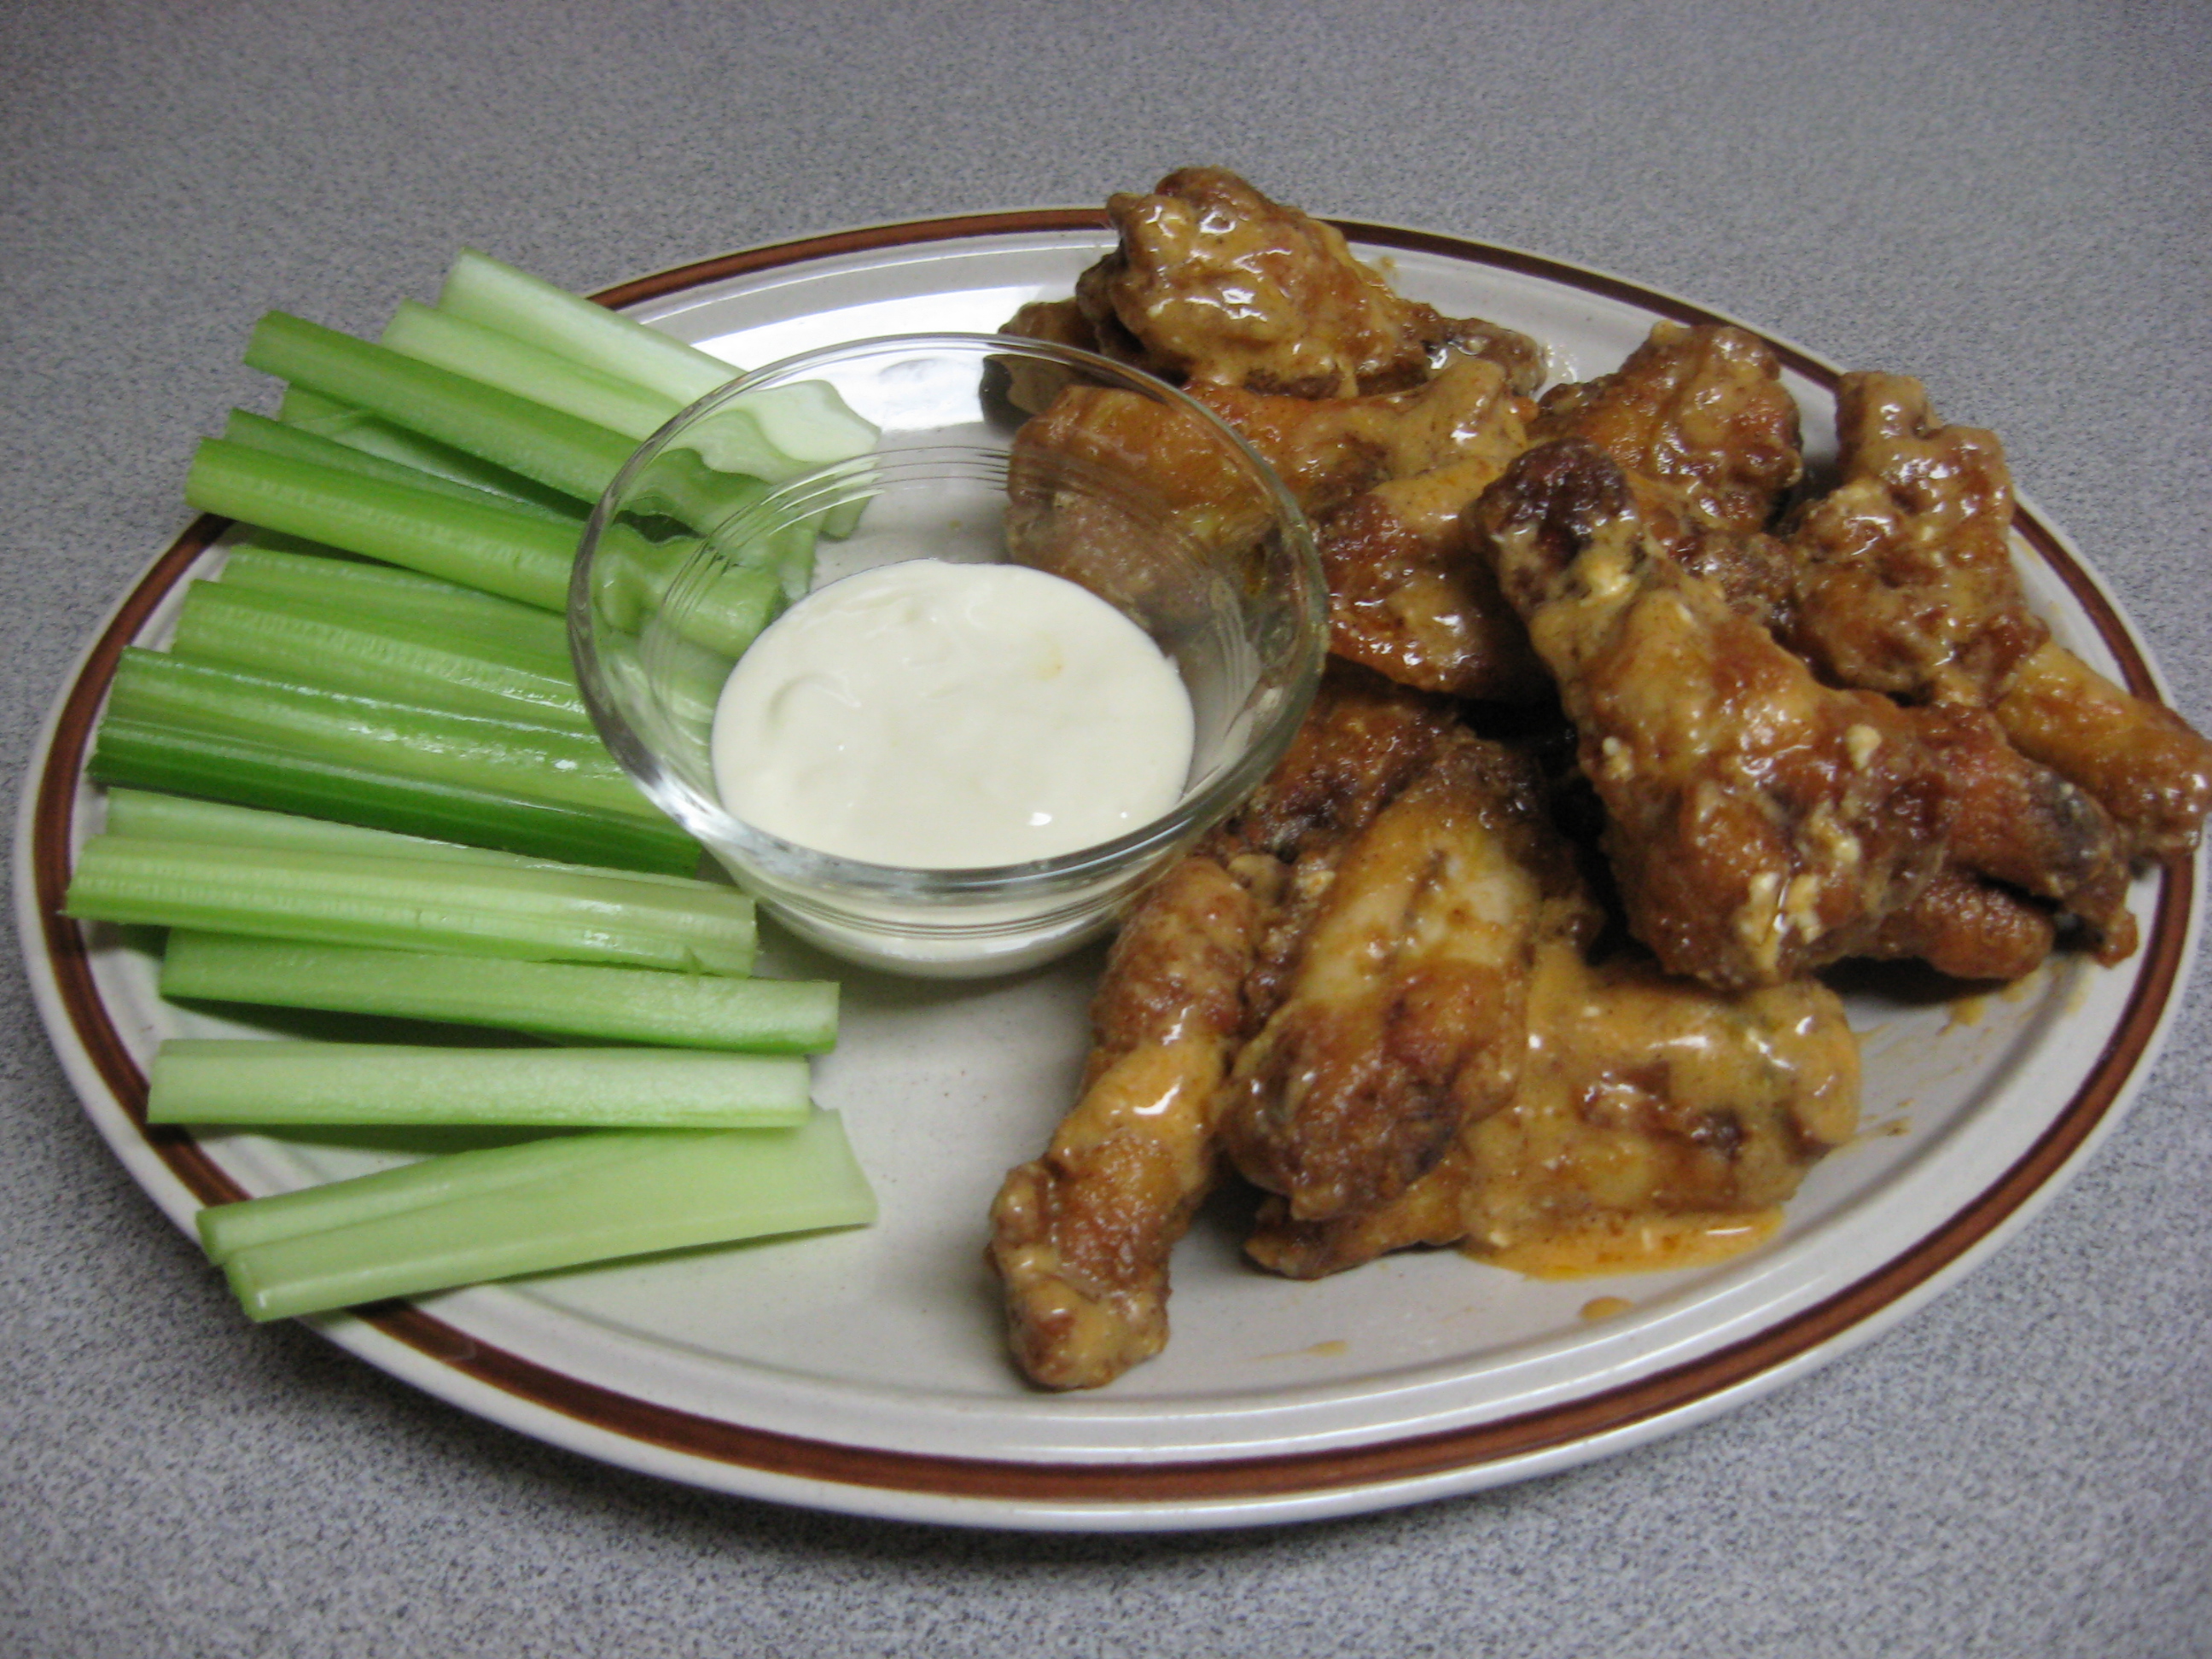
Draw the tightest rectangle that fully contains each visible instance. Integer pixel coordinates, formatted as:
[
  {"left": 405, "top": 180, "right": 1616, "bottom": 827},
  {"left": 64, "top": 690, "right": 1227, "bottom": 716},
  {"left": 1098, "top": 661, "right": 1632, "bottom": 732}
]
[{"left": 713, "top": 560, "right": 1192, "bottom": 870}]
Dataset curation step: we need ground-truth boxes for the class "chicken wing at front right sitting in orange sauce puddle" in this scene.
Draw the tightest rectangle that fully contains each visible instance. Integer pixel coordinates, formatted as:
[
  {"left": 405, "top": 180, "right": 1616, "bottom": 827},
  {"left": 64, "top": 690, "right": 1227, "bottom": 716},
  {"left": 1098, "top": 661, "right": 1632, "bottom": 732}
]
[{"left": 1245, "top": 931, "right": 1858, "bottom": 1278}]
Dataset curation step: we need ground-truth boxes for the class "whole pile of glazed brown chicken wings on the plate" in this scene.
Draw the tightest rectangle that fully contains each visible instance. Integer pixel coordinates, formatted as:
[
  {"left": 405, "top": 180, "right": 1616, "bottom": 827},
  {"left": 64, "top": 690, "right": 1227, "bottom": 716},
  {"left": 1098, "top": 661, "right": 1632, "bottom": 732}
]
[{"left": 989, "top": 168, "right": 2212, "bottom": 1389}]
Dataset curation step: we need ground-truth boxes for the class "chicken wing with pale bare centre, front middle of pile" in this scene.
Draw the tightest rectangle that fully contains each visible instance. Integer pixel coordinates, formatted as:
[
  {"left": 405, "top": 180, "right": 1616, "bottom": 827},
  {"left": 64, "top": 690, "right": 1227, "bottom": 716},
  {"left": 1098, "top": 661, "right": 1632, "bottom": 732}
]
[{"left": 1221, "top": 732, "right": 1570, "bottom": 1221}]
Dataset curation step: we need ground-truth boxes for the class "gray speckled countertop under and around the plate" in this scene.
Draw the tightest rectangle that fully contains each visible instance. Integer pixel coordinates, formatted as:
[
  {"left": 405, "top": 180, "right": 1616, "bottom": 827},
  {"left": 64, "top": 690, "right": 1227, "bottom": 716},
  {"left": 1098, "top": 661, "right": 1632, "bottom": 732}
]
[{"left": 0, "top": 0, "right": 2212, "bottom": 1659}]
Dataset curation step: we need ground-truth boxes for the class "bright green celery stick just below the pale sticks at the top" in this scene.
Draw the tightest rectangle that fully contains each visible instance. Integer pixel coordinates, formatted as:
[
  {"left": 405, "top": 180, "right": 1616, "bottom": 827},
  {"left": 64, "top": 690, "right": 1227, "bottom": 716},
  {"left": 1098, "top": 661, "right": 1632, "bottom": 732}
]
[{"left": 246, "top": 311, "right": 637, "bottom": 502}]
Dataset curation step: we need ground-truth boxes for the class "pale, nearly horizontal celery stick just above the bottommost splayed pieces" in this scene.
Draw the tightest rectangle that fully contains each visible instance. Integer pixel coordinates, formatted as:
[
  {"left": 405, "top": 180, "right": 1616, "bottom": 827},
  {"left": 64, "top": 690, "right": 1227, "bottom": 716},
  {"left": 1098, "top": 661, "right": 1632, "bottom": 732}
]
[{"left": 146, "top": 1038, "right": 812, "bottom": 1128}]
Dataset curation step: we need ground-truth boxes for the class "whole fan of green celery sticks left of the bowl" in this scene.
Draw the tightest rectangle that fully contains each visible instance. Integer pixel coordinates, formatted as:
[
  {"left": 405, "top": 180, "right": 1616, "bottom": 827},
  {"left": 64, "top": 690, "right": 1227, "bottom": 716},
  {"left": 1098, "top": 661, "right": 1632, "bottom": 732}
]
[{"left": 67, "top": 252, "right": 876, "bottom": 1318}]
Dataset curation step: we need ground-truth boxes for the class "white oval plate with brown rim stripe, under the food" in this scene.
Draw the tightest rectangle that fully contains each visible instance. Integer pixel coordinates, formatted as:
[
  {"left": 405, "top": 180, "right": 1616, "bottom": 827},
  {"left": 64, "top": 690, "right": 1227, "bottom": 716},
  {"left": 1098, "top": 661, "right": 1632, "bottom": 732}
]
[{"left": 18, "top": 210, "right": 2198, "bottom": 1531}]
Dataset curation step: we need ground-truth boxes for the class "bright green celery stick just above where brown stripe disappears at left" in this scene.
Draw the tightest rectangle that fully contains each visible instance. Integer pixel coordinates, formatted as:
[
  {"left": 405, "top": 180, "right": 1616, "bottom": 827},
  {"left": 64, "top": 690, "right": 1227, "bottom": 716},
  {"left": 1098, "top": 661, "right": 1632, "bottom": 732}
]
[{"left": 183, "top": 438, "right": 578, "bottom": 610}]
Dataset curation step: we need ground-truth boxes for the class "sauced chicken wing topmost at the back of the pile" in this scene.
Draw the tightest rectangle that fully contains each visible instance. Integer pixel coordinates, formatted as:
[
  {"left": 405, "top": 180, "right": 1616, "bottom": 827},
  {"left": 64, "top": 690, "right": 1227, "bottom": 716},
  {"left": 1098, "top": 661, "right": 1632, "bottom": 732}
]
[{"left": 1075, "top": 168, "right": 1544, "bottom": 399}]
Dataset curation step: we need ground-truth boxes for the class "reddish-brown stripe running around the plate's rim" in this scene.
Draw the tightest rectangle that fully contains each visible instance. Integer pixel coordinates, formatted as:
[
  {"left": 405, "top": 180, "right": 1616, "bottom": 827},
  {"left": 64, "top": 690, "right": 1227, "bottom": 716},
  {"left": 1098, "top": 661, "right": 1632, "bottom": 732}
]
[{"left": 31, "top": 208, "right": 2197, "bottom": 1505}]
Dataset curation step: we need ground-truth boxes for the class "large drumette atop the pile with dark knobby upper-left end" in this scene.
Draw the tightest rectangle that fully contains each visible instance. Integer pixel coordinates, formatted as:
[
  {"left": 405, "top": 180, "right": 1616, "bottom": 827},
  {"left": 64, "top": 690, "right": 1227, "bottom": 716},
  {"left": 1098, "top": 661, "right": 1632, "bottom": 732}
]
[{"left": 1476, "top": 438, "right": 1949, "bottom": 991}]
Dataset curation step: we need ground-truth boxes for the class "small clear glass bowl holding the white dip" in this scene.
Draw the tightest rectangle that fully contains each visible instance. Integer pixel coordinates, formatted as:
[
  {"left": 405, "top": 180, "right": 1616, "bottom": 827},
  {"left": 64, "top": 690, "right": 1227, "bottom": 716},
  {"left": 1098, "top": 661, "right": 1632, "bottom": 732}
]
[{"left": 568, "top": 334, "right": 1327, "bottom": 978}]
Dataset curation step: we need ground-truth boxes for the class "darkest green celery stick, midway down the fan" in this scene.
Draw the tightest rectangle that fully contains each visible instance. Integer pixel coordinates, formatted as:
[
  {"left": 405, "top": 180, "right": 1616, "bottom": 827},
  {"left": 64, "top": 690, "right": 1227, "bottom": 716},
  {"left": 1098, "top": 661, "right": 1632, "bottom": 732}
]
[{"left": 86, "top": 714, "right": 699, "bottom": 878}]
